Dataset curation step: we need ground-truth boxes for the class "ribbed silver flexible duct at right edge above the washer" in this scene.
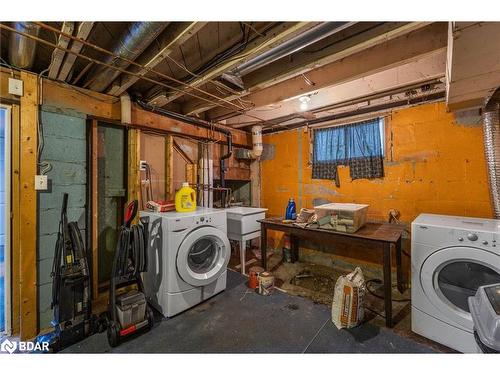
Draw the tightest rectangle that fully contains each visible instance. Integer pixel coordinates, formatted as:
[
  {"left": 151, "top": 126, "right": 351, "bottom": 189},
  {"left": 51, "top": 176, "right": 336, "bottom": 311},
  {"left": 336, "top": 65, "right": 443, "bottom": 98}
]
[{"left": 483, "top": 89, "right": 500, "bottom": 219}]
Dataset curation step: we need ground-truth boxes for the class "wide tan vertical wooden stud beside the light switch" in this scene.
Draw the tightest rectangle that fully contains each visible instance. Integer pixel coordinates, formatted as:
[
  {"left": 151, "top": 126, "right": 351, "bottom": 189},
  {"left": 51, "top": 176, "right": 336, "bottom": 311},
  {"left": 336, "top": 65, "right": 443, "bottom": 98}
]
[{"left": 19, "top": 72, "right": 38, "bottom": 340}]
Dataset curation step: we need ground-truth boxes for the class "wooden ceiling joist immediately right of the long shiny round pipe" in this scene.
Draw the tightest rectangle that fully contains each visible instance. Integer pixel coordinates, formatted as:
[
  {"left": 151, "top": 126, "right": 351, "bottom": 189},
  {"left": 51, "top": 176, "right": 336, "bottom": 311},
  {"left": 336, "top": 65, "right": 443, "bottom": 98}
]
[{"left": 183, "top": 22, "right": 429, "bottom": 115}]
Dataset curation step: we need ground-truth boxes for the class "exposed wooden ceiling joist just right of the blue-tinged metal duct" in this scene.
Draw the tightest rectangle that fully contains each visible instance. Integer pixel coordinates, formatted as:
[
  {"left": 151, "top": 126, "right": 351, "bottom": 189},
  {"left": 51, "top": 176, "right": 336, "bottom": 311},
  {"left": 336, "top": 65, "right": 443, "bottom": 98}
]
[{"left": 108, "top": 22, "right": 207, "bottom": 96}]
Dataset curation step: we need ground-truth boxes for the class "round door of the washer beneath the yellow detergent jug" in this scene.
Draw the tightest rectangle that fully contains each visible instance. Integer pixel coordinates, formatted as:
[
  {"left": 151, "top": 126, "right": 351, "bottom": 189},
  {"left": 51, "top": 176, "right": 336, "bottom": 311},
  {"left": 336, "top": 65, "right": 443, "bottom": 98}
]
[{"left": 177, "top": 227, "right": 231, "bottom": 286}]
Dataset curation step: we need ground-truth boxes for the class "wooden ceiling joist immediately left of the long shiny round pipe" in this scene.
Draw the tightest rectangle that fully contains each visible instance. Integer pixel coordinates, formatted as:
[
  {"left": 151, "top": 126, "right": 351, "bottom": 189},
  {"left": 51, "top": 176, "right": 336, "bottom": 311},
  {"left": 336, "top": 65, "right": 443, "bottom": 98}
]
[{"left": 149, "top": 22, "right": 315, "bottom": 106}]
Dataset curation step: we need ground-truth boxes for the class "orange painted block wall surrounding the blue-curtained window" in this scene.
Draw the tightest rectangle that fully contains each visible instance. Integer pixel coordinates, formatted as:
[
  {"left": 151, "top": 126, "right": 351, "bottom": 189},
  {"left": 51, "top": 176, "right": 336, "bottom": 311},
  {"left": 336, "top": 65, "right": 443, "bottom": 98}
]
[{"left": 262, "top": 103, "right": 492, "bottom": 223}]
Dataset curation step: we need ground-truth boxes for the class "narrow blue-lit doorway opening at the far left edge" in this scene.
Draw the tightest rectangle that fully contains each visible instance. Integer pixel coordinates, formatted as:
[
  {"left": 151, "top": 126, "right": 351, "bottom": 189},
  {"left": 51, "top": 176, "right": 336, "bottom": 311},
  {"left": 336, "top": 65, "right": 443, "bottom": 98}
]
[{"left": 0, "top": 105, "right": 11, "bottom": 336}]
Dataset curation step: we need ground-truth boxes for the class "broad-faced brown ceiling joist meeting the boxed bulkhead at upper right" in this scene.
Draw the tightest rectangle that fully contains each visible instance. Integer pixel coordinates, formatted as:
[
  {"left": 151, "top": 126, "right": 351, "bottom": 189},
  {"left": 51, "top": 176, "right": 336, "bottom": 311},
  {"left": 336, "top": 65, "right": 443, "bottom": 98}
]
[{"left": 208, "top": 23, "right": 447, "bottom": 119}]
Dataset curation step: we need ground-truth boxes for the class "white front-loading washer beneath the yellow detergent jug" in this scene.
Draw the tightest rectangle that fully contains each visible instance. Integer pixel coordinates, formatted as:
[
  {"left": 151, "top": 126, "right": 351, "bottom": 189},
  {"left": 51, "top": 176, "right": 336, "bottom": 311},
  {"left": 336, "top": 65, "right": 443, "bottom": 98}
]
[{"left": 140, "top": 208, "right": 231, "bottom": 317}]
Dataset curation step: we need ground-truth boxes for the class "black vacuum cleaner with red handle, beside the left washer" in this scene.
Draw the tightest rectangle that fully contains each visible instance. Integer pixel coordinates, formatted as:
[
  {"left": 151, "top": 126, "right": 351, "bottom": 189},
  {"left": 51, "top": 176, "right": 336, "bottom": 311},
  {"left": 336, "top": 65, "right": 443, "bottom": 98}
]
[{"left": 107, "top": 200, "right": 154, "bottom": 347}]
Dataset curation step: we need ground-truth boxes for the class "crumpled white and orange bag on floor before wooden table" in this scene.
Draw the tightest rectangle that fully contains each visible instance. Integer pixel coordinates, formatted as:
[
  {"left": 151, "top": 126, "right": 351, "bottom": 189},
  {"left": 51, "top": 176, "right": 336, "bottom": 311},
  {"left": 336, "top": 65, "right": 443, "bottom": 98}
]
[{"left": 332, "top": 267, "right": 365, "bottom": 329}]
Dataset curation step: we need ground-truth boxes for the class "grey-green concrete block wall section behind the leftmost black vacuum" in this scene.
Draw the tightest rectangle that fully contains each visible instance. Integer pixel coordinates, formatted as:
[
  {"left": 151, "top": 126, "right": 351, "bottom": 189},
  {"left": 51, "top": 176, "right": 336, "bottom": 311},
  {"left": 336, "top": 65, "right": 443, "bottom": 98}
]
[{"left": 37, "top": 111, "right": 87, "bottom": 329}]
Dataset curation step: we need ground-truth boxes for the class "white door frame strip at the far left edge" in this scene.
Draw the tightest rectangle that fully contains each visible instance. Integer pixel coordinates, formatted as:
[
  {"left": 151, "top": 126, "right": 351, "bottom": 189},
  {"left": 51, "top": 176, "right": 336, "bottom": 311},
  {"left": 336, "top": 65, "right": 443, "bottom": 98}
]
[{"left": 0, "top": 104, "right": 12, "bottom": 336}]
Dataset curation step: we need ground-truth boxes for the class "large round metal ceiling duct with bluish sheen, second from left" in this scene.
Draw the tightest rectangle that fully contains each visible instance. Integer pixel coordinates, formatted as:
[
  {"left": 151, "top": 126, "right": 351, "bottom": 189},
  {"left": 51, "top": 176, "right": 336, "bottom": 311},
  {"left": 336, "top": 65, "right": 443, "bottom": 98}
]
[{"left": 84, "top": 22, "right": 167, "bottom": 92}]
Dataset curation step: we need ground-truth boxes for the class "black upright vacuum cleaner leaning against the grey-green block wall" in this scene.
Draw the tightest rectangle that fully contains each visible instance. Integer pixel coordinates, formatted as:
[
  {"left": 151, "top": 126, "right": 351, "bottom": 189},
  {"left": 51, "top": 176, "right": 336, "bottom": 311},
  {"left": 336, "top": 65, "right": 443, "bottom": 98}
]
[{"left": 48, "top": 193, "right": 97, "bottom": 351}]
